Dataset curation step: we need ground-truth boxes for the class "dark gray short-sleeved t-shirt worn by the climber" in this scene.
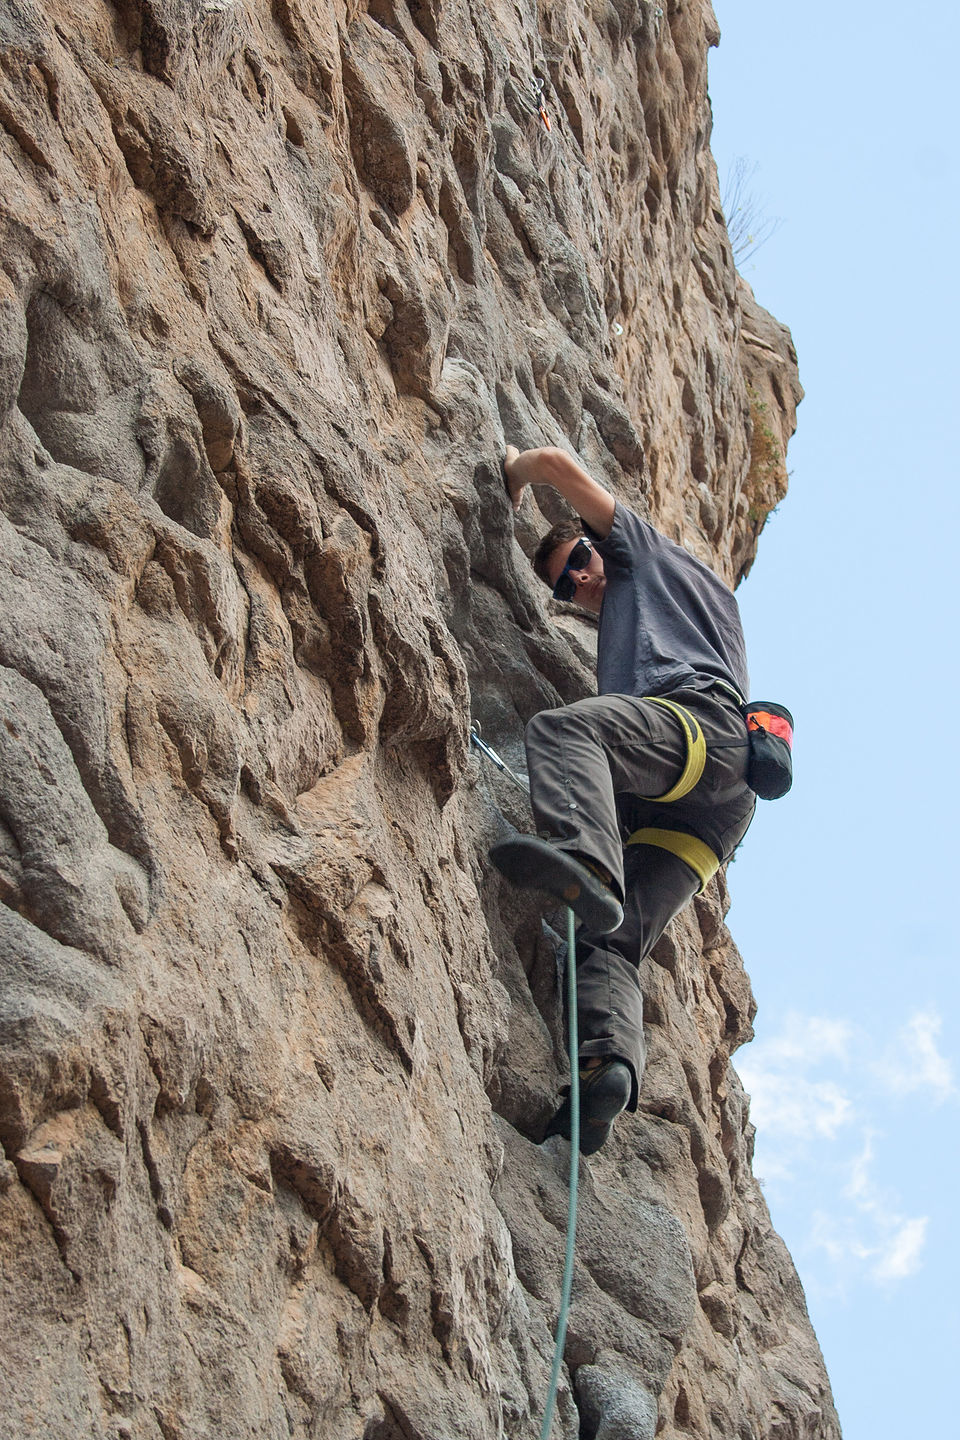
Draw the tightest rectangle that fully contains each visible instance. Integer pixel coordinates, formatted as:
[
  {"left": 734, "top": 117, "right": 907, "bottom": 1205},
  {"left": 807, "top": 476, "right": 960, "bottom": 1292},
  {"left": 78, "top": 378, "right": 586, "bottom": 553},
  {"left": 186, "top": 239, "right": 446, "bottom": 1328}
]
[{"left": 584, "top": 501, "right": 748, "bottom": 700}]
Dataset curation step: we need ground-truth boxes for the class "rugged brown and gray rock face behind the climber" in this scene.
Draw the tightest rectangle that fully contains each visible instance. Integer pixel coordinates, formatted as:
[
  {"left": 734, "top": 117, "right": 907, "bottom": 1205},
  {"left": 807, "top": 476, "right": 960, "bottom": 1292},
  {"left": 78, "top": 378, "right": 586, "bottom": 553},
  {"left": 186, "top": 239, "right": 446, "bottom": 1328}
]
[{"left": 0, "top": 0, "right": 839, "bottom": 1440}]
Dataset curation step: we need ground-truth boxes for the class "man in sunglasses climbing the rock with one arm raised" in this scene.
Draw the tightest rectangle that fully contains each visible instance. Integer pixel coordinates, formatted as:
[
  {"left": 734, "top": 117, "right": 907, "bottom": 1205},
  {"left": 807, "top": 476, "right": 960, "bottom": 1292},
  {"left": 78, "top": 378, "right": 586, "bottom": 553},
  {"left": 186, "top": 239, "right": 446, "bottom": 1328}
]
[{"left": 491, "top": 445, "right": 756, "bottom": 1155}]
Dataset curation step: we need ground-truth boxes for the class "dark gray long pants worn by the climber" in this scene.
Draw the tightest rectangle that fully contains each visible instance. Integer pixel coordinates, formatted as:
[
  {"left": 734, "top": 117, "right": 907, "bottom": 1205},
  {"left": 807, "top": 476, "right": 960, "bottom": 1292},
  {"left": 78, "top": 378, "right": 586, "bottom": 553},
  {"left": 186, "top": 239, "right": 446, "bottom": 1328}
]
[{"left": 525, "top": 687, "right": 756, "bottom": 1110}]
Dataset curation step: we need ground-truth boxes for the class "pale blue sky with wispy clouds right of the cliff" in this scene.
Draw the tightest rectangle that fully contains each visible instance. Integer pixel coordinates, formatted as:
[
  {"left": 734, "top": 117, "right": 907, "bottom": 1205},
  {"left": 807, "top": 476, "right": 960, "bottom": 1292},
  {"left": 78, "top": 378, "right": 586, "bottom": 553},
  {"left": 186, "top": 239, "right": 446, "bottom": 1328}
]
[{"left": 710, "top": 0, "right": 960, "bottom": 1440}]
